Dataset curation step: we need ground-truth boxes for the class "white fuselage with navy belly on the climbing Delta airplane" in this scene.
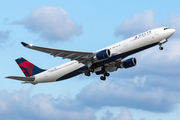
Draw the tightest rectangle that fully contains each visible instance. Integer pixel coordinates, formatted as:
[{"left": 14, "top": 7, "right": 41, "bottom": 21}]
[{"left": 32, "top": 27, "right": 175, "bottom": 84}]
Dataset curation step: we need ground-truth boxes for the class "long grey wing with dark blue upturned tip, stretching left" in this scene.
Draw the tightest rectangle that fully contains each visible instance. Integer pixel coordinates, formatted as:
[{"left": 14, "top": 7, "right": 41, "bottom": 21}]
[{"left": 21, "top": 42, "right": 94, "bottom": 64}]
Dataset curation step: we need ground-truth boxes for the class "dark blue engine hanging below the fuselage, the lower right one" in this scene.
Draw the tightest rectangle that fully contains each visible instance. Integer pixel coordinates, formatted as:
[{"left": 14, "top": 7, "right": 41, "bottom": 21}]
[{"left": 120, "top": 58, "right": 137, "bottom": 68}]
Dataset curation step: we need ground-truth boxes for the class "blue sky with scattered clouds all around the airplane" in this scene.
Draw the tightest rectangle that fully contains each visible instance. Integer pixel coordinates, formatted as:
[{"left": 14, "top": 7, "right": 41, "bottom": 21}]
[{"left": 0, "top": 0, "right": 180, "bottom": 120}]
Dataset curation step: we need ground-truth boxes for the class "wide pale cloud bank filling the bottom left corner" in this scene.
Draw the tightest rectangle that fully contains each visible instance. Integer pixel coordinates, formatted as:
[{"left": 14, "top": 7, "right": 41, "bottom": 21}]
[{"left": 0, "top": 90, "right": 96, "bottom": 120}]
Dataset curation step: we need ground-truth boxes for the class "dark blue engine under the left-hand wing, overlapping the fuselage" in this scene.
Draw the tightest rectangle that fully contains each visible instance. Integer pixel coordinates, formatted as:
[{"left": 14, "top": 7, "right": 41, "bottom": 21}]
[{"left": 94, "top": 49, "right": 111, "bottom": 60}]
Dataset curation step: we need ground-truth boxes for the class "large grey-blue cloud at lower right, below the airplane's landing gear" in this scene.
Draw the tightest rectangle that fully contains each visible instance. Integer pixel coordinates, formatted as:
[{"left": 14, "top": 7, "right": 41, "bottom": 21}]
[{"left": 77, "top": 79, "right": 180, "bottom": 112}]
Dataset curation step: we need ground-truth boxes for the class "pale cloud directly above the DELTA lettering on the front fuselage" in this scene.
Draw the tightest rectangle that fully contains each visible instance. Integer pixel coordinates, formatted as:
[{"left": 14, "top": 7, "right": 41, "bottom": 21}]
[{"left": 115, "top": 10, "right": 162, "bottom": 38}]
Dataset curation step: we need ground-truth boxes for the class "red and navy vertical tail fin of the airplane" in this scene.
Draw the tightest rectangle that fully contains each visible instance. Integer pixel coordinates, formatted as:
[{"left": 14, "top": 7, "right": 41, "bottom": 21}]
[{"left": 16, "top": 58, "right": 45, "bottom": 77}]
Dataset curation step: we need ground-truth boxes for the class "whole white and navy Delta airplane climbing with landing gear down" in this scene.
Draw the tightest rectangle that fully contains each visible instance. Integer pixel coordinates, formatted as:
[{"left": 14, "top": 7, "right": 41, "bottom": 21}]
[{"left": 6, "top": 27, "right": 175, "bottom": 85}]
